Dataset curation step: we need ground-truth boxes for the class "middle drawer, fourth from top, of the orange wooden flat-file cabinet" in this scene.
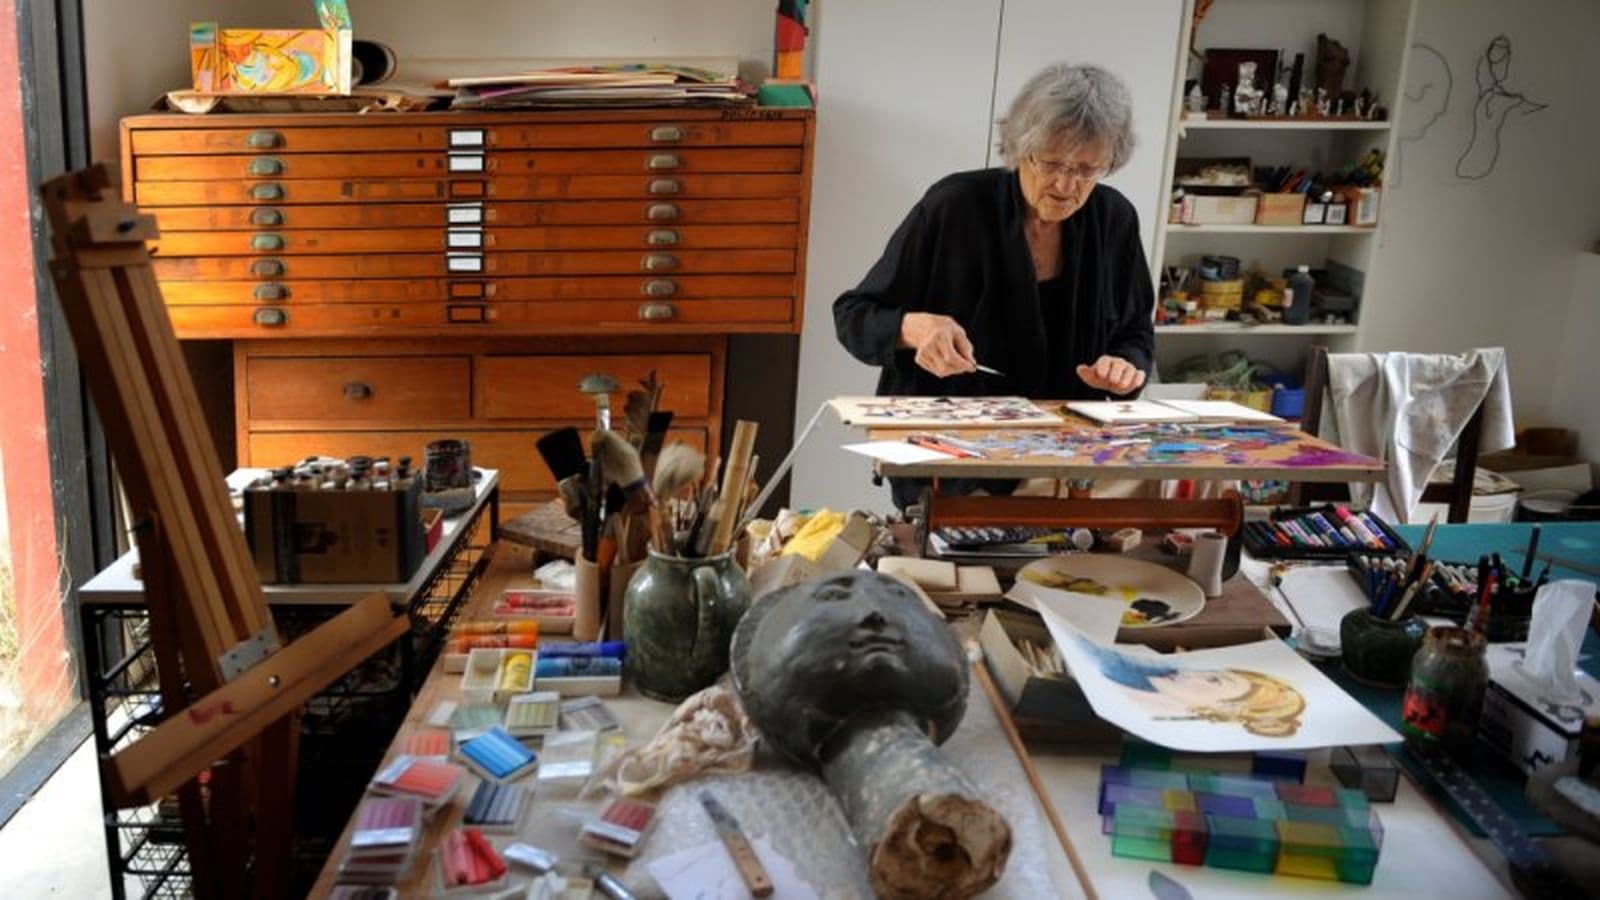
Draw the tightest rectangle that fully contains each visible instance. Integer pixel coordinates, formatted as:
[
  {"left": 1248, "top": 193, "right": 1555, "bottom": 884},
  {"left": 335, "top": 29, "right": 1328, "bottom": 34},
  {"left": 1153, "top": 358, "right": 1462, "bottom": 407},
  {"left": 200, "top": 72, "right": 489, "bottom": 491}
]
[{"left": 155, "top": 197, "right": 800, "bottom": 229}]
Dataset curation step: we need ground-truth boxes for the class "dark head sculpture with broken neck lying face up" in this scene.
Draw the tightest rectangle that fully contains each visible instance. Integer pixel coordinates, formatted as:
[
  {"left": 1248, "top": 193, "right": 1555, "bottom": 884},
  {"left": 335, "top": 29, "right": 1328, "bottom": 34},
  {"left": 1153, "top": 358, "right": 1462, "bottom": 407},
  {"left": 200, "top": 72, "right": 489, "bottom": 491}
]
[{"left": 730, "top": 572, "right": 1011, "bottom": 898}]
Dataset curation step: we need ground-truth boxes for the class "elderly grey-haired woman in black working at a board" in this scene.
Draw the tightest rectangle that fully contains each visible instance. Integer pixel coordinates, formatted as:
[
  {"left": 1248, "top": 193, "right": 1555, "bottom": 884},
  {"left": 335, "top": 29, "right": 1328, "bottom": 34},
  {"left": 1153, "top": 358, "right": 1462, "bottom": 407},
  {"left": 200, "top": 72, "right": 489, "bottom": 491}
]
[{"left": 834, "top": 64, "right": 1155, "bottom": 399}]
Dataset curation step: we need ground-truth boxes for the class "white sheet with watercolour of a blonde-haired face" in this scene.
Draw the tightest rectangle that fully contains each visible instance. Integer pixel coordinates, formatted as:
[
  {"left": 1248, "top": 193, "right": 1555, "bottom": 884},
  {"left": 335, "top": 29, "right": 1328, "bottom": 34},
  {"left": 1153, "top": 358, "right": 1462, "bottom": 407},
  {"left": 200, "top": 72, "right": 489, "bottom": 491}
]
[{"left": 1040, "top": 607, "right": 1400, "bottom": 753}]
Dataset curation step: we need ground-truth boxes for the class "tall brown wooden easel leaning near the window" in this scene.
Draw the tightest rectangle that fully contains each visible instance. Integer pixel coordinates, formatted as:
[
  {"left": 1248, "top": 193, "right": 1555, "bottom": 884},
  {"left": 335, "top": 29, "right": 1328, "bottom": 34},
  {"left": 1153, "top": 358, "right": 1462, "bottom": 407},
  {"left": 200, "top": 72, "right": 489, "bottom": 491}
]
[{"left": 42, "top": 167, "right": 406, "bottom": 897}]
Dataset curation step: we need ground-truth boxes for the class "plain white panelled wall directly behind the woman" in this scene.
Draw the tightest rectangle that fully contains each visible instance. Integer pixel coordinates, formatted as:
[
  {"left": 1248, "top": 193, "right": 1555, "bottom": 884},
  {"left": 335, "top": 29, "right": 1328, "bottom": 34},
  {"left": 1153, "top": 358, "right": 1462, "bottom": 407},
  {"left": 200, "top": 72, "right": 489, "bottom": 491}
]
[{"left": 792, "top": 0, "right": 1181, "bottom": 509}]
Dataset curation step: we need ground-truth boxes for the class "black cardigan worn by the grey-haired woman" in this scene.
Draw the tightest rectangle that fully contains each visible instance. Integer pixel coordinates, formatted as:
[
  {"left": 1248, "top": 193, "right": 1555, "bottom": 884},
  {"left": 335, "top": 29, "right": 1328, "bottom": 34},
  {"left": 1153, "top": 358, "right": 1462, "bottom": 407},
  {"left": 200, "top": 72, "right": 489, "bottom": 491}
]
[{"left": 834, "top": 168, "right": 1155, "bottom": 399}]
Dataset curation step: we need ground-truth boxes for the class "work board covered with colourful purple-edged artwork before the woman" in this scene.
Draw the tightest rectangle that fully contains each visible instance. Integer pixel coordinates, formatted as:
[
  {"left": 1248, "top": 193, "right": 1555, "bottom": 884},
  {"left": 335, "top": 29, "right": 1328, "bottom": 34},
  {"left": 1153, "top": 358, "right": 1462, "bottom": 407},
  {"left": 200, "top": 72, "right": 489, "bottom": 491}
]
[{"left": 867, "top": 415, "right": 1384, "bottom": 482}]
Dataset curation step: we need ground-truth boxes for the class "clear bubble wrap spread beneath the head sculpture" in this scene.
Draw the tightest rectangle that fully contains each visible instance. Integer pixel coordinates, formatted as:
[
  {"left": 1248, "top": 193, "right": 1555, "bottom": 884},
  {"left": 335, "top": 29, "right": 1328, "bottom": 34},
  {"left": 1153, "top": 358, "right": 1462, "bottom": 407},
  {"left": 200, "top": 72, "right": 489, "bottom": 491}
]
[{"left": 622, "top": 684, "right": 1061, "bottom": 900}]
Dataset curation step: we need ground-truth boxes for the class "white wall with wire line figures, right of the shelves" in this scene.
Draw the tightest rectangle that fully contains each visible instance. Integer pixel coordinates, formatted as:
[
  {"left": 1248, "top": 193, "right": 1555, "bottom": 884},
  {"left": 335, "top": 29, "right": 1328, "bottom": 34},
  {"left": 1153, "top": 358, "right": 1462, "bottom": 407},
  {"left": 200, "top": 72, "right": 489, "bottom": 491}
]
[{"left": 1362, "top": 0, "right": 1600, "bottom": 425}]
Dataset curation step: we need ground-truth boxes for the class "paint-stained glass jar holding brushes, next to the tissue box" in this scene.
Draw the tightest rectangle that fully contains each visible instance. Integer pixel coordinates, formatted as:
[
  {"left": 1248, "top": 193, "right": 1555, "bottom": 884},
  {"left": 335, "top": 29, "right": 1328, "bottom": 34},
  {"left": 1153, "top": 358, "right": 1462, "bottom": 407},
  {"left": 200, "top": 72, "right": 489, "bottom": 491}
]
[{"left": 1400, "top": 628, "right": 1490, "bottom": 753}]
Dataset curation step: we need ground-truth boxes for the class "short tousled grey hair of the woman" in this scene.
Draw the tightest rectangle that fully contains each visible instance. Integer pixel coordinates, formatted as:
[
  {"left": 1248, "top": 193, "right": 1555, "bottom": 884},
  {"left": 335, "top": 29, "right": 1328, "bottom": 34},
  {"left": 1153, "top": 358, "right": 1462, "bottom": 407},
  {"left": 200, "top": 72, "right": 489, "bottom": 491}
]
[{"left": 998, "top": 62, "right": 1133, "bottom": 171}]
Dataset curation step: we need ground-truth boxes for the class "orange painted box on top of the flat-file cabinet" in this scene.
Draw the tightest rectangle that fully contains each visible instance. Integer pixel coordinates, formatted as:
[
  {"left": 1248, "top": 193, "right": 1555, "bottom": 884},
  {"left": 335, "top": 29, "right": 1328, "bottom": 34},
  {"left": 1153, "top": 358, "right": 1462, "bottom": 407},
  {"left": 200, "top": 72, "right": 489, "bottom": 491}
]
[{"left": 189, "top": 0, "right": 352, "bottom": 94}]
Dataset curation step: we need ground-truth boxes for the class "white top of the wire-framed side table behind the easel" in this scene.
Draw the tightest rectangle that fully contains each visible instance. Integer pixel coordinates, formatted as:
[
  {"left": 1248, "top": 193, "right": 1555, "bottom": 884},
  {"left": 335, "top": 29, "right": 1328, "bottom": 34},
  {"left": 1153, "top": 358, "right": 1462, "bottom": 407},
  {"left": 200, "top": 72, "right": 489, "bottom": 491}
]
[{"left": 78, "top": 468, "right": 499, "bottom": 605}]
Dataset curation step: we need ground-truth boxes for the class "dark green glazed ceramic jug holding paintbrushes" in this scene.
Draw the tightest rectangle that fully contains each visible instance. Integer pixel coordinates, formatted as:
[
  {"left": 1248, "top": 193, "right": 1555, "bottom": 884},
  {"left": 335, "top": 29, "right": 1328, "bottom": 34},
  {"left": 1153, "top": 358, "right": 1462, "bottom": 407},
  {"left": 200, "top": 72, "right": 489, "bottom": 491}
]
[{"left": 622, "top": 551, "right": 750, "bottom": 703}]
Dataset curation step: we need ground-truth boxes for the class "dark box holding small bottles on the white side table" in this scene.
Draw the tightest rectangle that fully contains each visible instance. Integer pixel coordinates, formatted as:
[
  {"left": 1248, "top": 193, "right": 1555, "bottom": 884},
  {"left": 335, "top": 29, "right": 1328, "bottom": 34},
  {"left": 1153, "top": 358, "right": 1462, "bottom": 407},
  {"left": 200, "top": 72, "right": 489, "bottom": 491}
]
[{"left": 245, "top": 479, "right": 427, "bottom": 585}]
